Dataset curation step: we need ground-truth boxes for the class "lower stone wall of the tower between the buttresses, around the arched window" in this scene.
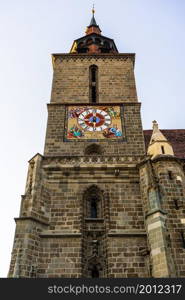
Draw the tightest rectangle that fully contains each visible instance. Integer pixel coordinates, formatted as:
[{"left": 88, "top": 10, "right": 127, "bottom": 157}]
[{"left": 38, "top": 164, "right": 149, "bottom": 277}]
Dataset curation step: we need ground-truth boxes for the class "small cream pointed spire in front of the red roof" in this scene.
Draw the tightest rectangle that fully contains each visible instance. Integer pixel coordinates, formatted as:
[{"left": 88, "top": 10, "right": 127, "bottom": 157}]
[{"left": 147, "top": 121, "right": 174, "bottom": 158}]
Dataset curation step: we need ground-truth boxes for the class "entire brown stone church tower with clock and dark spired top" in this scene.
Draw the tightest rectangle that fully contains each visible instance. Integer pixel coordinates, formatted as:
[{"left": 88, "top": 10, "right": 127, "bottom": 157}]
[{"left": 8, "top": 11, "right": 185, "bottom": 278}]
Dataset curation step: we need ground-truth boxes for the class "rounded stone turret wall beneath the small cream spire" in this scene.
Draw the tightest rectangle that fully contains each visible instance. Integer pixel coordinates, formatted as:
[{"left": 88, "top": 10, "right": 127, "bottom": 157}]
[{"left": 155, "top": 159, "right": 185, "bottom": 277}]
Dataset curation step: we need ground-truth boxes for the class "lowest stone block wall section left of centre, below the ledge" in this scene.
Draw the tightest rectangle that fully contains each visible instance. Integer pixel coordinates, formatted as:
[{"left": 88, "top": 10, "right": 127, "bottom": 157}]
[{"left": 38, "top": 234, "right": 82, "bottom": 278}]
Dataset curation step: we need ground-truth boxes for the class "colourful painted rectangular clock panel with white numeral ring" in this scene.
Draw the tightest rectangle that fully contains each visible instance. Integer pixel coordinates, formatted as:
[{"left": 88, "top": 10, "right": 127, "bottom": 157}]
[{"left": 66, "top": 106, "right": 123, "bottom": 140}]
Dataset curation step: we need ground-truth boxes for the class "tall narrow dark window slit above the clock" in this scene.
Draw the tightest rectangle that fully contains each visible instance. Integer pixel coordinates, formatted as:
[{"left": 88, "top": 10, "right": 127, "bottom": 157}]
[{"left": 89, "top": 65, "right": 98, "bottom": 103}]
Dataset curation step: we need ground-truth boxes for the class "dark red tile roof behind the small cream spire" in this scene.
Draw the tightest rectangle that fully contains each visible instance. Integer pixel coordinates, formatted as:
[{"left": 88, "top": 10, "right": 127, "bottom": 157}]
[{"left": 143, "top": 129, "right": 185, "bottom": 158}]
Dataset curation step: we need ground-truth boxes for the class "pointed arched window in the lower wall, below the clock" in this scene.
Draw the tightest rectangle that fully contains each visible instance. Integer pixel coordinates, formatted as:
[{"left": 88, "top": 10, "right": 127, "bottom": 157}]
[{"left": 84, "top": 185, "right": 102, "bottom": 219}]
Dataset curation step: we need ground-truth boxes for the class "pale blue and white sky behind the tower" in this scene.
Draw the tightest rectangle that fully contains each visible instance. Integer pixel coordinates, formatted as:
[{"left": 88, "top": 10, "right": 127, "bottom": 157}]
[{"left": 0, "top": 0, "right": 185, "bottom": 277}]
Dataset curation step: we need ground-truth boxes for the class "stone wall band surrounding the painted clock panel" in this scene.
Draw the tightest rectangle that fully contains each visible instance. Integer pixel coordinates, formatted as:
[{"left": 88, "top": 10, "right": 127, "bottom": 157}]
[{"left": 44, "top": 104, "right": 145, "bottom": 156}]
